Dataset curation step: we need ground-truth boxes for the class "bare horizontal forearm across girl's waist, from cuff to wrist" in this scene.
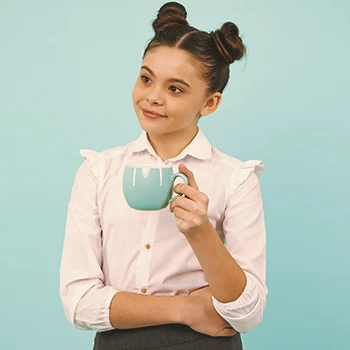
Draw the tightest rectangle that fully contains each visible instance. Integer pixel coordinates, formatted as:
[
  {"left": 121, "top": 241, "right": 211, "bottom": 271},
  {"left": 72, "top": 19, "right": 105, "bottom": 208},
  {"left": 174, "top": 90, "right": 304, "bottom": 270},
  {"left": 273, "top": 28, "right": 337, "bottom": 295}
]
[{"left": 110, "top": 292, "right": 187, "bottom": 329}]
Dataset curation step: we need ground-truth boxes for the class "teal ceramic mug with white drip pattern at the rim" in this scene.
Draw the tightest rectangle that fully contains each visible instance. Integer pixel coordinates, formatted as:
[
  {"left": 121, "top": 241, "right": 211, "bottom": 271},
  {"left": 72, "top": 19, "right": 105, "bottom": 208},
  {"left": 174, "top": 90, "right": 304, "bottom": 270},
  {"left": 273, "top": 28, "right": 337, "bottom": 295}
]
[{"left": 123, "top": 164, "right": 188, "bottom": 210}]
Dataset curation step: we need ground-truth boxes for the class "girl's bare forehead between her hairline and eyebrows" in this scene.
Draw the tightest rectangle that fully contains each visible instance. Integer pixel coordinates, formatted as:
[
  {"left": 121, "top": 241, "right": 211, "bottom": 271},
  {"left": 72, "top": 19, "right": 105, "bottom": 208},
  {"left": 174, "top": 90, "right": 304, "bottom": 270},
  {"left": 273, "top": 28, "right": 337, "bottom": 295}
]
[{"left": 142, "top": 46, "right": 201, "bottom": 81}]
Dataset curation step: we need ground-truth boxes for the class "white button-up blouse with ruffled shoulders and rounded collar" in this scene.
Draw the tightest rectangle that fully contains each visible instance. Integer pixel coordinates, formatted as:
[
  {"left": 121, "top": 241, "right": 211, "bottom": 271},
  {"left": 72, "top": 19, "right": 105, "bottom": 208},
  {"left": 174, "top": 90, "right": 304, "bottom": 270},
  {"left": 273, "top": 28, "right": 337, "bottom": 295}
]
[{"left": 60, "top": 129, "right": 268, "bottom": 333}]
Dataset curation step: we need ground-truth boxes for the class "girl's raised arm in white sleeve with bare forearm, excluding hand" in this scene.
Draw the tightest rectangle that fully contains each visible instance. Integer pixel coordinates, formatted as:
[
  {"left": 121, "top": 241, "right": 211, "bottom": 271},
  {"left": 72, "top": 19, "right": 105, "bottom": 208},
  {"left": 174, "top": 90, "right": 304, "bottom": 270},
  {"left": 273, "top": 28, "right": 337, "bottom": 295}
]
[{"left": 174, "top": 161, "right": 267, "bottom": 333}]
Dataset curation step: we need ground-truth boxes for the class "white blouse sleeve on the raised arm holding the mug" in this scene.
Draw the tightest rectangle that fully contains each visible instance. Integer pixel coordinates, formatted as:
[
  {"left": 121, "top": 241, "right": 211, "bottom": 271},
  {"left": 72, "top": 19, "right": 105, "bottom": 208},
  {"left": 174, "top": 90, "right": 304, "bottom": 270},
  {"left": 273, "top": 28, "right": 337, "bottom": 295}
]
[{"left": 212, "top": 160, "right": 268, "bottom": 333}]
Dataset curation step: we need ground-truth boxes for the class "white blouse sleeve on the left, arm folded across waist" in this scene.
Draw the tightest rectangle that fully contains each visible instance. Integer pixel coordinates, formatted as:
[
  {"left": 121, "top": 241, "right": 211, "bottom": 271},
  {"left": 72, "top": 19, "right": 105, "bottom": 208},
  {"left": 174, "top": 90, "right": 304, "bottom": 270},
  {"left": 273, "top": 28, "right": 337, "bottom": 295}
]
[{"left": 60, "top": 150, "right": 118, "bottom": 332}]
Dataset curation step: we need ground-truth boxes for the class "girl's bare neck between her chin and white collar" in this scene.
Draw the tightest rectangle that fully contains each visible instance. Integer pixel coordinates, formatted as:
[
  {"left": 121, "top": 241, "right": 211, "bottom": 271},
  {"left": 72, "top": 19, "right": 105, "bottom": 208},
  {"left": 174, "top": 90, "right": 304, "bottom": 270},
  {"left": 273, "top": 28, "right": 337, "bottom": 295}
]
[{"left": 147, "top": 125, "right": 198, "bottom": 162}]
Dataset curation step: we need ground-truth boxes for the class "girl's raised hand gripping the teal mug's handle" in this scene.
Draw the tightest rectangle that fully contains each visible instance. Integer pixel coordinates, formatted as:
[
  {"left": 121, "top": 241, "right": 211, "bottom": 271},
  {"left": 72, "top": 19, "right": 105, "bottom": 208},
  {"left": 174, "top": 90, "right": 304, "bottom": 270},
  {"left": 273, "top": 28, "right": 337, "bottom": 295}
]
[{"left": 170, "top": 164, "right": 210, "bottom": 237}]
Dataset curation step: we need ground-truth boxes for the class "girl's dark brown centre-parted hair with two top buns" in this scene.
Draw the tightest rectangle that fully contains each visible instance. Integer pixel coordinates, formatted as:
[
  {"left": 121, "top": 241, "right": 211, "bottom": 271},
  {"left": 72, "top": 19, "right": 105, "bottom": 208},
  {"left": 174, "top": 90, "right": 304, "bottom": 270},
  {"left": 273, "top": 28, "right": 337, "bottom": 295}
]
[{"left": 142, "top": 2, "right": 246, "bottom": 94}]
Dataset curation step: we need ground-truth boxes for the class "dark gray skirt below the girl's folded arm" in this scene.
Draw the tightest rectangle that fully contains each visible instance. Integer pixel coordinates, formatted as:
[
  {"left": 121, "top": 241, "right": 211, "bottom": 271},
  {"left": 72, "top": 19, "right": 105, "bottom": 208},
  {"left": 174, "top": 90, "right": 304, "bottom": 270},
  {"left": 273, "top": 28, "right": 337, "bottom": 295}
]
[{"left": 93, "top": 323, "right": 243, "bottom": 350}]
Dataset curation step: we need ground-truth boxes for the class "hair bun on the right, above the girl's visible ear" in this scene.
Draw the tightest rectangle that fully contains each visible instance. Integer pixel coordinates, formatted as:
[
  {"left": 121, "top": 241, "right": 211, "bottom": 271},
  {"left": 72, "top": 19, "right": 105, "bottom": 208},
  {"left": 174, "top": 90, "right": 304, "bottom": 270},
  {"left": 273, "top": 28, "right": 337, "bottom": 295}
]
[{"left": 210, "top": 22, "right": 246, "bottom": 64}]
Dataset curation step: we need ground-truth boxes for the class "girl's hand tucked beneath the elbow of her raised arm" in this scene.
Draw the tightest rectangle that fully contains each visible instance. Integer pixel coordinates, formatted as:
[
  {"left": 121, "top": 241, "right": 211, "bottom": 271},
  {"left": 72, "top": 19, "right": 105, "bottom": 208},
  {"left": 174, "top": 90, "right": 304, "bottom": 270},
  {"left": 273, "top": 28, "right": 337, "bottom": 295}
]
[{"left": 184, "top": 286, "right": 236, "bottom": 337}]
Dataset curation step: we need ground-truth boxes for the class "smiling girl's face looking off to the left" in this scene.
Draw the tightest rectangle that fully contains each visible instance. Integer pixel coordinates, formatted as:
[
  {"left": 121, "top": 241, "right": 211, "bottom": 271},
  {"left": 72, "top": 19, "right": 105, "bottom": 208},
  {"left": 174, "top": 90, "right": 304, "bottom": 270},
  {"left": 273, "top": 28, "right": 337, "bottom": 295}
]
[{"left": 132, "top": 46, "right": 219, "bottom": 135}]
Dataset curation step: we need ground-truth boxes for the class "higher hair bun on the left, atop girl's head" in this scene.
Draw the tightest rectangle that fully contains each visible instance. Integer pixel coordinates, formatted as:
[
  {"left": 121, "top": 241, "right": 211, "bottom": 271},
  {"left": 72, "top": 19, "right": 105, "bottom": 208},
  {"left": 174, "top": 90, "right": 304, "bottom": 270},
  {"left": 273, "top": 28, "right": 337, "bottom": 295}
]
[{"left": 152, "top": 2, "right": 188, "bottom": 34}]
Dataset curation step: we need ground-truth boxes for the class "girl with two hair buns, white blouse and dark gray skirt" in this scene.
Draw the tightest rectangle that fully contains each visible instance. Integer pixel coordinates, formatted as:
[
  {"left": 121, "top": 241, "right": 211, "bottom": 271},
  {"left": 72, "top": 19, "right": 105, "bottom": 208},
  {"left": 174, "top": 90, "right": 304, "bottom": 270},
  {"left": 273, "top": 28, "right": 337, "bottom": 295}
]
[{"left": 60, "top": 2, "right": 267, "bottom": 350}]
